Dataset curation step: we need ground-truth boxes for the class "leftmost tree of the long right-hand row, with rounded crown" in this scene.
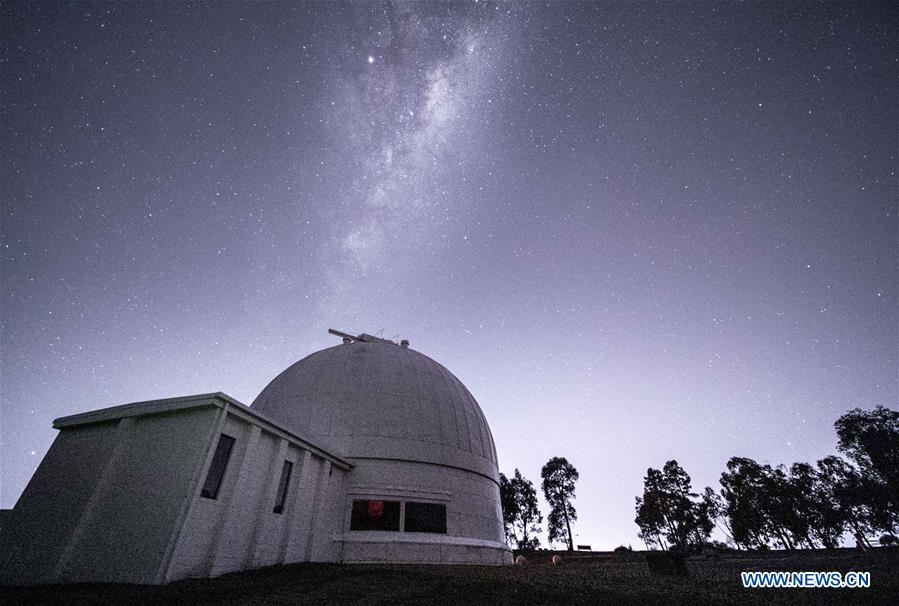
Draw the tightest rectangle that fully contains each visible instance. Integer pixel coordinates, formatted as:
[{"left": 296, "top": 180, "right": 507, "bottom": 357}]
[{"left": 634, "top": 461, "right": 714, "bottom": 551}]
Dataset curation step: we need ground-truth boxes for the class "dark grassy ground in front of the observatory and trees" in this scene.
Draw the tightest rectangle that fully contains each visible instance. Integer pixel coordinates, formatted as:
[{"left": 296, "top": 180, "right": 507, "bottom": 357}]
[{"left": 0, "top": 549, "right": 899, "bottom": 606}]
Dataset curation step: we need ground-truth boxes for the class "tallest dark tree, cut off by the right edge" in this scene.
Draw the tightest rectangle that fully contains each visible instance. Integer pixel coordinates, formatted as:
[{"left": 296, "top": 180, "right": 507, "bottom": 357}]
[{"left": 834, "top": 406, "right": 899, "bottom": 533}]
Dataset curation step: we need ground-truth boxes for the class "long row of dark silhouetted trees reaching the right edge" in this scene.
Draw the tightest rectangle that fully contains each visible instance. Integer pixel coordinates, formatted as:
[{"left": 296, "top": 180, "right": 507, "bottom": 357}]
[{"left": 634, "top": 406, "right": 899, "bottom": 551}]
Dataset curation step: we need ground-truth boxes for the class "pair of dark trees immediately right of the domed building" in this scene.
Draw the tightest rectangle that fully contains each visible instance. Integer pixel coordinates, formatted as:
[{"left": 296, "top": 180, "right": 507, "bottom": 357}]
[{"left": 499, "top": 457, "right": 580, "bottom": 551}]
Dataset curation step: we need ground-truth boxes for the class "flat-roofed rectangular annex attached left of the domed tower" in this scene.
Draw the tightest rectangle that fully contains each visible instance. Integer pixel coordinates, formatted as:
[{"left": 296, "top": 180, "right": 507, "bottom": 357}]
[{"left": 0, "top": 395, "right": 345, "bottom": 584}]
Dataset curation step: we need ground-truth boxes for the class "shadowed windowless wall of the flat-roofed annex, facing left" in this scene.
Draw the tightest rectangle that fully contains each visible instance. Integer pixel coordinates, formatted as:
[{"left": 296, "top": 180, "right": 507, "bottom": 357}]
[{"left": 0, "top": 407, "right": 216, "bottom": 583}]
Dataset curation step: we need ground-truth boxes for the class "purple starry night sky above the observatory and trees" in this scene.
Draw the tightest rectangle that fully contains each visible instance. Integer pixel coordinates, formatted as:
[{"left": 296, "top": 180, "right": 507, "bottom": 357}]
[{"left": 0, "top": 1, "right": 899, "bottom": 549}]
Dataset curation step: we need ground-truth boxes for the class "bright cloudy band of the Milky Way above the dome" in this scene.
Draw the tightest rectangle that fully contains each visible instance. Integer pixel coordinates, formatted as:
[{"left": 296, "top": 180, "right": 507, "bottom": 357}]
[{"left": 322, "top": 3, "right": 512, "bottom": 315}]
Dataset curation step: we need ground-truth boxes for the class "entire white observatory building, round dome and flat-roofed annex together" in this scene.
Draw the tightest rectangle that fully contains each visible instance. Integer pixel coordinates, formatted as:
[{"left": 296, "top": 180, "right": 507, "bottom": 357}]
[{"left": 0, "top": 330, "right": 512, "bottom": 584}]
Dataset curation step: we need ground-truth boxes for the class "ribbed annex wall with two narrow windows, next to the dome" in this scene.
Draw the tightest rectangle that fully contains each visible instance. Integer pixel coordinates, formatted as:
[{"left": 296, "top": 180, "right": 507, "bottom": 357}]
[{"left": 166, "top": 414, "right": 345, "bottom": 580}]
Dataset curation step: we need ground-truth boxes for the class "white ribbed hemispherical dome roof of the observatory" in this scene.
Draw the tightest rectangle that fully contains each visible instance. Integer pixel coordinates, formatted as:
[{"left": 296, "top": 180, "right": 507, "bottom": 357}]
[{"left": 253, "top": 335, "right": 499, "bottom": 482}]
